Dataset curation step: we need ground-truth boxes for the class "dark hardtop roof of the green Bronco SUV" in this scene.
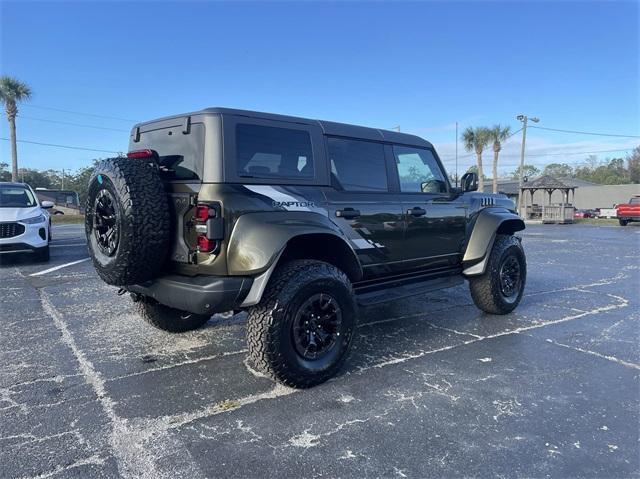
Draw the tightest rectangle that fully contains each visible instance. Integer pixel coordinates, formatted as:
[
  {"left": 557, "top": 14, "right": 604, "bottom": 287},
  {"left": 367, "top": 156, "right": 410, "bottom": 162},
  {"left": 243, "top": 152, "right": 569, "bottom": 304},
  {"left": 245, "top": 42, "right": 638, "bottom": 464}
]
[{"left": 133, "top": 107, "right": 433, "bottom": 148}]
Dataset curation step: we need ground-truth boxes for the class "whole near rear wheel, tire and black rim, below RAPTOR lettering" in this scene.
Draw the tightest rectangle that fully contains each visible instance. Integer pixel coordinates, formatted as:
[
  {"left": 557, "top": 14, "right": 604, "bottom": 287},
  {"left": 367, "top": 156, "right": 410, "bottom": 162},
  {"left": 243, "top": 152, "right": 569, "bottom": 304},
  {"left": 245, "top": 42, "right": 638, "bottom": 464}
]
[{"left": 247, "top": 260, "right": 357, "bottom": 388}]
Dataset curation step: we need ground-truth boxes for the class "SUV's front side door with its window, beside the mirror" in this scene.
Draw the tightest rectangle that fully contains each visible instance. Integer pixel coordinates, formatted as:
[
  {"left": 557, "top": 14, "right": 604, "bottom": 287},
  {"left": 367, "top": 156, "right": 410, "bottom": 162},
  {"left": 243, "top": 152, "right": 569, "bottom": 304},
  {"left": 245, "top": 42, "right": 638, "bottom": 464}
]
[{"left": 392, "top": 145, "right": 466, "bottom": 269}]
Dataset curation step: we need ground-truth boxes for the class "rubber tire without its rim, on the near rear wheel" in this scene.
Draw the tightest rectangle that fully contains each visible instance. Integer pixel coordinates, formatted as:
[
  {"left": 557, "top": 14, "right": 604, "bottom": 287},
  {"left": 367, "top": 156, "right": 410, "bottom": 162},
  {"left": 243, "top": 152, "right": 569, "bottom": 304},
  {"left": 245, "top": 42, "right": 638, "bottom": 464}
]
[{"left": 247, "top": 260, "right": 357, "bottom": 388}]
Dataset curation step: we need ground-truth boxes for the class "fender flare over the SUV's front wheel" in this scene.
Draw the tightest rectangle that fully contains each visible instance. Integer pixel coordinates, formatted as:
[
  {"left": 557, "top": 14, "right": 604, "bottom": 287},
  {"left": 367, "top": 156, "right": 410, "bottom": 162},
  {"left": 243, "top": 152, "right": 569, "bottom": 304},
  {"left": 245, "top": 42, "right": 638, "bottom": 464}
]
[{"left": 462, "top": 208, "right": 525, "bottom": 276}]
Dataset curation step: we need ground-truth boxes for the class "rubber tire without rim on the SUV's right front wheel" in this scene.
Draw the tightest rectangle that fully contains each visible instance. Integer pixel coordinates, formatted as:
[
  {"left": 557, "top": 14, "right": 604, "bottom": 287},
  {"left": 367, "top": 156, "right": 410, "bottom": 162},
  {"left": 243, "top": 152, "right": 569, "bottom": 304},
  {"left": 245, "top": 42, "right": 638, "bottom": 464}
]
[{"left": 469, "top": 235, "right": 527, "bottom": 314}]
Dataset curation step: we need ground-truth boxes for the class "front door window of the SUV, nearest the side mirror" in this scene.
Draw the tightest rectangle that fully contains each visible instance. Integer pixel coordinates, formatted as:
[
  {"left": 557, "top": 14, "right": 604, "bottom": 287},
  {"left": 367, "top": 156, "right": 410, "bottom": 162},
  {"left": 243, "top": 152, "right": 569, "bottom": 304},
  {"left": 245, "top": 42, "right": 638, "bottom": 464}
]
[{"left": 393, "top": 146, "right": 447, "bottom": 193}]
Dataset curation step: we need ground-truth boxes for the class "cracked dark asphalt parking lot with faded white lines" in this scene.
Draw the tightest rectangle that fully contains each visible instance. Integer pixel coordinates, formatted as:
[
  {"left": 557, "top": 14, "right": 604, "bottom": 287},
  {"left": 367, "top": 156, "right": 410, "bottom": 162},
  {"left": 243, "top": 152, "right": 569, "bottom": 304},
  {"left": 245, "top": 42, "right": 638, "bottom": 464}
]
[{"left": 0, "top": 225, "right": 640, "bottom": 478}]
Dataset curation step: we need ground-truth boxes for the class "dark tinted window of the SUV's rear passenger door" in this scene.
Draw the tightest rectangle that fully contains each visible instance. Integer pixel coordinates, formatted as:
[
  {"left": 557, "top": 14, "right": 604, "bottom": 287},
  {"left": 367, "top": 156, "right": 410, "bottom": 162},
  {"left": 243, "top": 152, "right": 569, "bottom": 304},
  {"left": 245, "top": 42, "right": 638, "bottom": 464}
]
[{"left": 327, "top": 137, "right": 388, "bottom": 191}]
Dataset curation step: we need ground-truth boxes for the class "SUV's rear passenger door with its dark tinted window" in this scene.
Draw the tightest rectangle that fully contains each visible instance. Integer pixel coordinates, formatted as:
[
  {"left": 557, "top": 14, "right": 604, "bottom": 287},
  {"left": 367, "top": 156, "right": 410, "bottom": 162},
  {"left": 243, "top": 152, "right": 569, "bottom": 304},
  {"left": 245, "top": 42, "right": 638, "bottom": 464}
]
[{"left": 325, "top": 137, "right": 404, "bottom": 279}]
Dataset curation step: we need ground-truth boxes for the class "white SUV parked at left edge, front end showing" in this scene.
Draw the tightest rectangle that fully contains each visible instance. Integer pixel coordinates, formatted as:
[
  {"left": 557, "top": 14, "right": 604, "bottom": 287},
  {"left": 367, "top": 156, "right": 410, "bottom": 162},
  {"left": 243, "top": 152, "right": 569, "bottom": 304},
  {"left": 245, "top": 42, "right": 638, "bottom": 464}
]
[{"left": 0, "top": 182, "right": 53, "bottom": 261}]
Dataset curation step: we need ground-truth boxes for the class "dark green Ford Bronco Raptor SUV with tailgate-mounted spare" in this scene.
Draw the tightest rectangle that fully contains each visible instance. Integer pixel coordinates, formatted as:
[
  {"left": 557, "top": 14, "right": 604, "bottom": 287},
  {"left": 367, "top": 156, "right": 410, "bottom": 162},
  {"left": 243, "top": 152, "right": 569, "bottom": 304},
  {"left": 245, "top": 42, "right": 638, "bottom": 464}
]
[{"left": 85, "top": 108, "right": 526, "bottom": 387}]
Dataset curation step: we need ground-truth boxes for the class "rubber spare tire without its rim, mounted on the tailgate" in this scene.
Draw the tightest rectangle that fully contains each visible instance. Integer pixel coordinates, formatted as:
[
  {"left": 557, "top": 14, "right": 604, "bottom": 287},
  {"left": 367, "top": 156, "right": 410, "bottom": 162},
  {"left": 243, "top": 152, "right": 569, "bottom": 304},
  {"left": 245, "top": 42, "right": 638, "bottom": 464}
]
[{"left": 85, "top": 158, "right": 171, "bottom": 286}]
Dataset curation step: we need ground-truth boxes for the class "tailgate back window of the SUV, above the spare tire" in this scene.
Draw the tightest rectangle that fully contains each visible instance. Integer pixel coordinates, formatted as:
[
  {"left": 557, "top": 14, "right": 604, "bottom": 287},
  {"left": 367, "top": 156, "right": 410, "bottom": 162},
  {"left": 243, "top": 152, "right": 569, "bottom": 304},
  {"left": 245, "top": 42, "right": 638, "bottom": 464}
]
[{"left": 131, "top": 123, "right": 204, "bottom": 180}]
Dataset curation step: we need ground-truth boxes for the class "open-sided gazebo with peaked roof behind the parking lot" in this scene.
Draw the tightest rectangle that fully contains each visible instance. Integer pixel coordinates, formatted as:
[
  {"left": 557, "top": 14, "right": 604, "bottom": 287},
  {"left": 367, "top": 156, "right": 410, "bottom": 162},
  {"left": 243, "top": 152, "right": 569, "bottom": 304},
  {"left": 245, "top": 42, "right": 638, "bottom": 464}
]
[{"left": 520, "top": 175, "right": 577, "bottom": 224}]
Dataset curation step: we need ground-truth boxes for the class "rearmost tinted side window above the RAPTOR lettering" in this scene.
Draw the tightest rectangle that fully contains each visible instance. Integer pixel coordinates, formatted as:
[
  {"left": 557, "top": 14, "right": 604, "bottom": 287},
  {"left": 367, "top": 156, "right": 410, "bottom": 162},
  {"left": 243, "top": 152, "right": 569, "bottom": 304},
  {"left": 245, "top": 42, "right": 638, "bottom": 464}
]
[{"left": 236, "top": 123, "right": 313, "bottom": 179}]
